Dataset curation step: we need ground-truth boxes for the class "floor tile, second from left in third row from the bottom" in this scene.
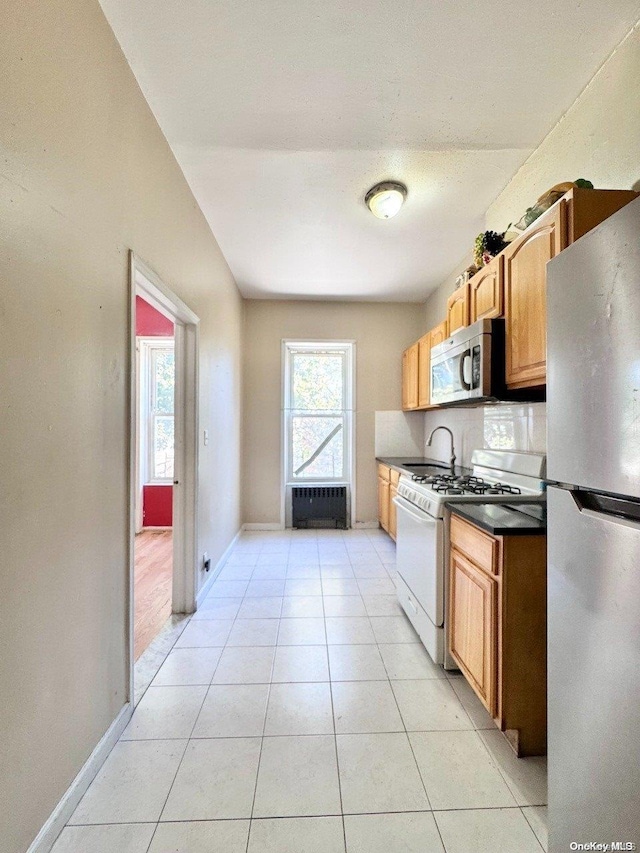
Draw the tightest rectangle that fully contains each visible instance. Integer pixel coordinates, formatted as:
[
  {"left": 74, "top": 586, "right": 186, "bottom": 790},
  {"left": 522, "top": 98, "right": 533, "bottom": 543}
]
[{"left": 192, "top": 684, "right": 269, "bottom": 738}]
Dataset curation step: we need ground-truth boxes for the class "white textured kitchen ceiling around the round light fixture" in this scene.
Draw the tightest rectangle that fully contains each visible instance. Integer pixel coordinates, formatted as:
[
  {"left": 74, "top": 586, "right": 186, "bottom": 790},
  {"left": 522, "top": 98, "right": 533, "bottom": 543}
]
[{"left": 101, "top": 0, "right": 640, "bottom": 301}]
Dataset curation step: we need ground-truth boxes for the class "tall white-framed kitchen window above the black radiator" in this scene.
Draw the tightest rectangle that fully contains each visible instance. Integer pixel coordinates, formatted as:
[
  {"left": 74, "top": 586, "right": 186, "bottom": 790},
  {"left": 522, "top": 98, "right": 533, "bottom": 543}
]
[{"left": 284, "top": 342, "right": 353, "bottom": 483}]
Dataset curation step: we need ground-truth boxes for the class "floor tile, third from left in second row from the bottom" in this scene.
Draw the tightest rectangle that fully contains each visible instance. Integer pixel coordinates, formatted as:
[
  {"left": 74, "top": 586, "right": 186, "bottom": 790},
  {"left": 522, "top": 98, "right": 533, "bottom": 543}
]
[{"left": 253, "top": 735, "right": 341, "bottom": 817}]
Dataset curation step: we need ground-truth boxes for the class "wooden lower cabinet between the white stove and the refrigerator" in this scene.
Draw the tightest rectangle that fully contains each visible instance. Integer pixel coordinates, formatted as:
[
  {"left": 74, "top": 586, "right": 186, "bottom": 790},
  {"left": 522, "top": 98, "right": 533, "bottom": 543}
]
[{"left": 448, "top": 514, "right": 547, "bottom": 755}]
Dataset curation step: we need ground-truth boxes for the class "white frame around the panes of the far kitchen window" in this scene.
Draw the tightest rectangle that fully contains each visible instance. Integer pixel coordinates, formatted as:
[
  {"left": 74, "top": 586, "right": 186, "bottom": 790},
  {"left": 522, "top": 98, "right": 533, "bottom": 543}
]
[{"left": 282, "top": 340, "right": 355, "bottom": 491}]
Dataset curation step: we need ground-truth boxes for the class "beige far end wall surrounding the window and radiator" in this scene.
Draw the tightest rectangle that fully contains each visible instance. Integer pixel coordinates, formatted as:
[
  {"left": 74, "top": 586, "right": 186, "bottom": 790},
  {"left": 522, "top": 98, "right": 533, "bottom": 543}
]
[{"left": 243, "top": 300, "right": 422, "bottom": 524}]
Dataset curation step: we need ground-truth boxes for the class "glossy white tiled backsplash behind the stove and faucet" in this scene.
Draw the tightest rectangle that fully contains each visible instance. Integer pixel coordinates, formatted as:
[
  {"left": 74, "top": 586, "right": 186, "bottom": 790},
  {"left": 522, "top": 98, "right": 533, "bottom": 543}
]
[{"left": 424, "top": 403, "right": 547, "bottom": 466}]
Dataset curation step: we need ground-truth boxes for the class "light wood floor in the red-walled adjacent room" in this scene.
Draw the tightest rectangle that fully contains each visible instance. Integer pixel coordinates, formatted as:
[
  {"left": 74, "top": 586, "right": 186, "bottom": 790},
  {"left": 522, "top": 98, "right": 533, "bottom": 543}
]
[{"left": 134, "top": 530, "right": 173, "bottom": 660}]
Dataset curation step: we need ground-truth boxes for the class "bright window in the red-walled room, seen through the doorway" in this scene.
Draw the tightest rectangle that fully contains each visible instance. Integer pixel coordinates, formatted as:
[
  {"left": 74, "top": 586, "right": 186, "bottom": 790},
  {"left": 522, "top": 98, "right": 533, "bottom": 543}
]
[{"left": 139, "top": 338, "right": 175, "bottom": 483}]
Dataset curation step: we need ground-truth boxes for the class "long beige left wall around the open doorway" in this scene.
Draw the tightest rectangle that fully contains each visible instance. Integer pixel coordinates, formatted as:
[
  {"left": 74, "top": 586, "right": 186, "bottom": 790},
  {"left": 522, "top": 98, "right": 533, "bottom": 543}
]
[{"left": 0, "top": 0, "right": 242, "bottom": 853}]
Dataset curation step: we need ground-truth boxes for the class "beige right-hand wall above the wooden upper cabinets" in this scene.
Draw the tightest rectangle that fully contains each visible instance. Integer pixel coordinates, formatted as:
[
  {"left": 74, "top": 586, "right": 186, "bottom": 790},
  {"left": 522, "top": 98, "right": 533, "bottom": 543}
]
[{"left": 425, "top": 24, "right": 640, "bottom": 328}]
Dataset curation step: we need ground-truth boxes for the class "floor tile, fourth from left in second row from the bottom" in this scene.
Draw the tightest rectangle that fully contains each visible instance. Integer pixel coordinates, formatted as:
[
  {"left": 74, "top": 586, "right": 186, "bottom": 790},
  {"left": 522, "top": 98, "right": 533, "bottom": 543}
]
[{"left": 337, "top": 734, "right": 429, "bottom": 814}]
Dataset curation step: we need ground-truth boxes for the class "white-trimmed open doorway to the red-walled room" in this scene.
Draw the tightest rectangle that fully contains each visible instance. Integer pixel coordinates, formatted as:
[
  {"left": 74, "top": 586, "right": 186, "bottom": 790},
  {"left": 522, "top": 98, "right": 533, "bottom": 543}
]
[{"left": 128, "top": 253, "right": 198, "bottom": 700}]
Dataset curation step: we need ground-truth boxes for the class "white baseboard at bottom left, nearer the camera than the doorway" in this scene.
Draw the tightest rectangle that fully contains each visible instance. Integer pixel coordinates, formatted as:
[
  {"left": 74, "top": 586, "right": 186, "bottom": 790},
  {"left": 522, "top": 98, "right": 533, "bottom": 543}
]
[{"left": 27, "top": 702, "right": 133, "bottom": 853}]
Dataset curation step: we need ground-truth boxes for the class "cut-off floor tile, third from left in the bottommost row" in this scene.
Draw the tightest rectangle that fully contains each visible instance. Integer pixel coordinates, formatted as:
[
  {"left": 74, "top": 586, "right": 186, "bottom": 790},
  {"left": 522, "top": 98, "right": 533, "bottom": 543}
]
[{"left": 248, "top": 817, "right": 345, "bottom": 853}]
